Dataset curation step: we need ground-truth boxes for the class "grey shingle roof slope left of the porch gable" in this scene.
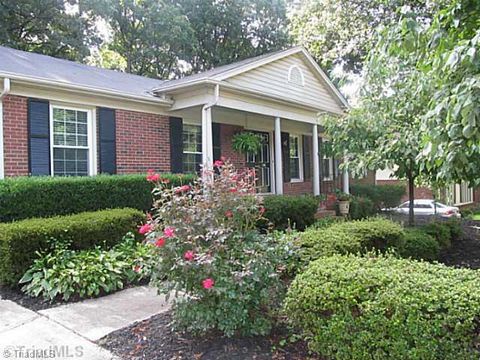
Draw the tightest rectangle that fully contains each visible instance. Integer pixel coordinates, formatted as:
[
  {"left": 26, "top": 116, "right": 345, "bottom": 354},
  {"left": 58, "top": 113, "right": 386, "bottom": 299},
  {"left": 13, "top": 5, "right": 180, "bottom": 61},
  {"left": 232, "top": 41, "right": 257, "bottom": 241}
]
[{"left": 0, "top": 46, "right": 163, "bottom": 98}]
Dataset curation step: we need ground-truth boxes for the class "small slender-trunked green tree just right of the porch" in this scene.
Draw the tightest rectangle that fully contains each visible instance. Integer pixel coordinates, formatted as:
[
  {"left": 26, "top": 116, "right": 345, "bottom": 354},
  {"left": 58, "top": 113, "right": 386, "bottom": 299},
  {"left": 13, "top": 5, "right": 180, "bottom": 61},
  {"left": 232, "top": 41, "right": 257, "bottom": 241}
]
[{"left": 326, "top": 10, "right": 431, "bottom": 224}]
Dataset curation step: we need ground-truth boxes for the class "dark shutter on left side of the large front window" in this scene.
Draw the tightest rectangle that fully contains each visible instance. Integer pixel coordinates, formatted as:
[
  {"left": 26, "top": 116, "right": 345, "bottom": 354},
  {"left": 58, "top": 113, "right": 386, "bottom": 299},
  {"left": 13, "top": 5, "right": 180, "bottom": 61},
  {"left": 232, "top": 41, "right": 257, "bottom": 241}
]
[{"left": 28, "top": 99, "right": 50, "bottom": 175}]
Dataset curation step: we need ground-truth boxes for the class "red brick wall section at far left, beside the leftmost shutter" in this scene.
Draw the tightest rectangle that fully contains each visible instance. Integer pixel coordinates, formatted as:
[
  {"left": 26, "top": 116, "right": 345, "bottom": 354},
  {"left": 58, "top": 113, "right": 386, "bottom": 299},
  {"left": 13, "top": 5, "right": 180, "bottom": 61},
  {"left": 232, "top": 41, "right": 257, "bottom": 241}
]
[{"left": 3, "top": 95, "right": 28, "bottom": 176}]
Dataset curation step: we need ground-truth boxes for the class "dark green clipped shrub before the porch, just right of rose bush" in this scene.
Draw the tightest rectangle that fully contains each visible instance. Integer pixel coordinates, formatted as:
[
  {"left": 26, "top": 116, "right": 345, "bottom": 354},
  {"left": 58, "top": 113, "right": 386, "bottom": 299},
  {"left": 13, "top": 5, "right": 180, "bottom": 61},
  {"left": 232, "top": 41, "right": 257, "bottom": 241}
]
[{"left": 263, "top": 195, "right": 320, "bottom": 230}]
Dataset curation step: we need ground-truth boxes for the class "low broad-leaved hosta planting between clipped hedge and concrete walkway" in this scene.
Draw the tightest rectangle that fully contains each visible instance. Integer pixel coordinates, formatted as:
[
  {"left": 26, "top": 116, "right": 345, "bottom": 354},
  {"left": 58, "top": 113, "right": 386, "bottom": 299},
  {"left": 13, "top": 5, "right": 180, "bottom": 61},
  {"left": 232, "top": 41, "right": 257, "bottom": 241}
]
[{"left": 20, "top": 233, "right": 154, "bottom": 301}]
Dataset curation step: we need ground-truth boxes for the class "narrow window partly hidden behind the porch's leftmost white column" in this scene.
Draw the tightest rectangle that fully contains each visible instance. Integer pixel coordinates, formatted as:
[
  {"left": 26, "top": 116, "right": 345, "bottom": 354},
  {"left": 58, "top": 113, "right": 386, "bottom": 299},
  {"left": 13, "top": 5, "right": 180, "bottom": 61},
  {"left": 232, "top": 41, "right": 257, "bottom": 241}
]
[{"left": 182, "top": 124, "right": 202, "bottom": 173}]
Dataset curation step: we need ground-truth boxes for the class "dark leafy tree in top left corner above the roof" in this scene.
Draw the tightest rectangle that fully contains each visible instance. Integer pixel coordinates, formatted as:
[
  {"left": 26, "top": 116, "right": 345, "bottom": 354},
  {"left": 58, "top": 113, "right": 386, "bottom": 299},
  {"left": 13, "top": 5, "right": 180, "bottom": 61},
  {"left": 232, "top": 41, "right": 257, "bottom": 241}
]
[{"left": 0, "top": 0, "right": 99, "bottom": 60}]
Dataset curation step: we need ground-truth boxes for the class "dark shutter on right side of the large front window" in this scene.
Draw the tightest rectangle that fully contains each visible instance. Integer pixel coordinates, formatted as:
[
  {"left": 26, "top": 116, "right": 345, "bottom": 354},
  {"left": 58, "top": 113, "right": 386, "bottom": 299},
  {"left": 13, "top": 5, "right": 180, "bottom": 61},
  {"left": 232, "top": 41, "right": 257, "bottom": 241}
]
[{"left": 98, "top": 108, "right": 117, "bottom": 174}]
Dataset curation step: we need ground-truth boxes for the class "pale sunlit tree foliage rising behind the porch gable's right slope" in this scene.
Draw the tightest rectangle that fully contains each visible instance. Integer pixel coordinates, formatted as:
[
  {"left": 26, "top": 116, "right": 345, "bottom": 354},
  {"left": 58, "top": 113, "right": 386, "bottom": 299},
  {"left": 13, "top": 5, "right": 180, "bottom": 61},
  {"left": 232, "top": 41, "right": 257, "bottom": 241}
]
[{"left": 290, "top": 0, "right": 438, "bottom": 72}]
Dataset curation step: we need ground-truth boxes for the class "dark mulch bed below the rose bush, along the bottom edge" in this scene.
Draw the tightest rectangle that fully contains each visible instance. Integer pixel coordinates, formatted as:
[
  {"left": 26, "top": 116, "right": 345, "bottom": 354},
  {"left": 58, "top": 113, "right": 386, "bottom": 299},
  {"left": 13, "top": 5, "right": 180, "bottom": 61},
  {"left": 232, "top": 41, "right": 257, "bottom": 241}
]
[{"left": 98, "top": 312, "right": 320, "bottom": 360}]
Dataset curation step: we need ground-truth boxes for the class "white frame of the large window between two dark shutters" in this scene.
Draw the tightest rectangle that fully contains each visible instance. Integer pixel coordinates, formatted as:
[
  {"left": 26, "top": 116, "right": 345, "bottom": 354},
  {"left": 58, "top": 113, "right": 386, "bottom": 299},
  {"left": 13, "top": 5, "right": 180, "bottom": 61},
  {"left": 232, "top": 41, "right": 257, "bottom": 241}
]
[{"left": 49, "top": 103, "right": 97, "bottom": 176}]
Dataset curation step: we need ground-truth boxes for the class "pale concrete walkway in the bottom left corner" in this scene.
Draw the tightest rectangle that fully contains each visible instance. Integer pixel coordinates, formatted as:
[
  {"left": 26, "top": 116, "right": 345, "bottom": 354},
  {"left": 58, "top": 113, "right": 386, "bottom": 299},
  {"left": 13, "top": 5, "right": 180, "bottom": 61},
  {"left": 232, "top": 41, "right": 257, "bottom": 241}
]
[{"left": 0, "top": 286, "right": 169, "bottom": 360}]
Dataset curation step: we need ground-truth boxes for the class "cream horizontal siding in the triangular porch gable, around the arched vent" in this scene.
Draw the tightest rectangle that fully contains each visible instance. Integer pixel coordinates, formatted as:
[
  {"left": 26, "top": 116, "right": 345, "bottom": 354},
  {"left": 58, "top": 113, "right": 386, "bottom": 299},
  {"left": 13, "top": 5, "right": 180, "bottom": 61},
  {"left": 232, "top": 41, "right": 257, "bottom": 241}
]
[{"left": 226, "top": 54, "right": 342, "bottom": 113}]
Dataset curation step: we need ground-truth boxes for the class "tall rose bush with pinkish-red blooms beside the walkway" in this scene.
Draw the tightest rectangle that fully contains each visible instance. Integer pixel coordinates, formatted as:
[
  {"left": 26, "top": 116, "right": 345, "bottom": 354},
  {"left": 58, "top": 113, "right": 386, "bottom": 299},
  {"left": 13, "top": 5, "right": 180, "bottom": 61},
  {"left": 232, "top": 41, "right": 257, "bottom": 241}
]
[{"left": 140, "top": 161, "right": 282, "bottom": 336}]
